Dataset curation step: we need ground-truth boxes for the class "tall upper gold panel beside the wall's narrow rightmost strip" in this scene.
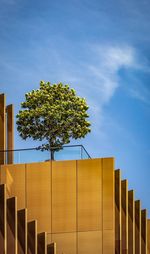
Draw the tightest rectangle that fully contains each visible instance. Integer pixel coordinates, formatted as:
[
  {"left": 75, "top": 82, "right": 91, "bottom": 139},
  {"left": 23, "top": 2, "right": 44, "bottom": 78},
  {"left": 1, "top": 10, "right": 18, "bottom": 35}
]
[{"left": 77, "top": 159, "right": 102, "bottom": 231}]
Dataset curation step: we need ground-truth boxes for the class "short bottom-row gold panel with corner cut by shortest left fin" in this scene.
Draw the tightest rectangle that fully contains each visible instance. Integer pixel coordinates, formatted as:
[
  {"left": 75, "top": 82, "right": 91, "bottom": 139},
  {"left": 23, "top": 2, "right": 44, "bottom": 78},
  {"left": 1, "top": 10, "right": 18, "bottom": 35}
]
[{"left": 52, "top": 233, "right": 77, "bottom": 254}]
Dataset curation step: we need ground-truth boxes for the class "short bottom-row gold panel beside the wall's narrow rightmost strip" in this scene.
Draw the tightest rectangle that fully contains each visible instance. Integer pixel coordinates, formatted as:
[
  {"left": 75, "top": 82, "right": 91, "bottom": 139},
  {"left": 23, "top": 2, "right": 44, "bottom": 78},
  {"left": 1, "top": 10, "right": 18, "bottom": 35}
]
[{"left": 77, "top": 231, "right": 102, "bottom": 254}]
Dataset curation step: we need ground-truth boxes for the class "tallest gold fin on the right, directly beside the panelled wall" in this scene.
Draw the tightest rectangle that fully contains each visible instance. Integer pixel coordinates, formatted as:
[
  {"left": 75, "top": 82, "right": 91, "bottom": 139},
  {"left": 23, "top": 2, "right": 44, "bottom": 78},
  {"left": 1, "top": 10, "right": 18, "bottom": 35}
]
[{"left": 115, "top": 170, "right": 121, "bottom": 254}]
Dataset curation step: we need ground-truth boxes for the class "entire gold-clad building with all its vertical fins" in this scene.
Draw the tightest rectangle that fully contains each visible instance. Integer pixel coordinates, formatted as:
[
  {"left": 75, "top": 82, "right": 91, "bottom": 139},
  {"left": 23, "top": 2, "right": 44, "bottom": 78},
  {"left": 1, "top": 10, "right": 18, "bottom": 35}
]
[{"left": 0, "top": 95, "right": 150, "bottom": 254}]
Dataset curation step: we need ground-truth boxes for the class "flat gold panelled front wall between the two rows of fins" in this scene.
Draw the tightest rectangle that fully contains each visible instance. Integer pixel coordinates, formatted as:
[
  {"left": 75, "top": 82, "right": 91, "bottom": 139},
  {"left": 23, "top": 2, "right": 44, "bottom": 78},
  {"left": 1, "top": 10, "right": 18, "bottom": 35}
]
[{"left": 0, "top": 158, "right": 115, "bottom": 254}]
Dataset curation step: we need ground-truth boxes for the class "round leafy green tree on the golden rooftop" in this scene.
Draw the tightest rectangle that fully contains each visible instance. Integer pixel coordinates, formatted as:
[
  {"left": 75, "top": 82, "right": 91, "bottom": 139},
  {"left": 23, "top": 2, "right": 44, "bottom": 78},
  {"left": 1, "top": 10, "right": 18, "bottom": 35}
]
[{"left": 17, "top": 81, "right": 91, "bottom": 159}]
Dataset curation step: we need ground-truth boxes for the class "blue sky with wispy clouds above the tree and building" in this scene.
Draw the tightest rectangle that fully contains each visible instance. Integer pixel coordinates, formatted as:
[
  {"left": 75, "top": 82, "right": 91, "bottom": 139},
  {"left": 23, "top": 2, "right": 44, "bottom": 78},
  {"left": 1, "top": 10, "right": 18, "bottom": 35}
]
[{"left": 0, "top": 0, "right": 150, "bottom": 214}]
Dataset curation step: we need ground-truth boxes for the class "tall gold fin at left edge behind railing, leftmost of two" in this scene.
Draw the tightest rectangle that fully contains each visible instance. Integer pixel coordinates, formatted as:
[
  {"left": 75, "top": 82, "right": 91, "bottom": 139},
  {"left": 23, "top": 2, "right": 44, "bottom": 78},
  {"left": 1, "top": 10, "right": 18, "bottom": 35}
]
[{"left": 0, "top": 94, "right": 6, "bottom": 165}]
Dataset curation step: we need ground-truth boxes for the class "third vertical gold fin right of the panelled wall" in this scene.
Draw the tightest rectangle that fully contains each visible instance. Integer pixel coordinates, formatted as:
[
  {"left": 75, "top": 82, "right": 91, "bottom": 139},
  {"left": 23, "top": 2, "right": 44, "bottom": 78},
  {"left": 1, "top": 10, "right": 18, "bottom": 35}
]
[{"left": 128, "top": 190, "right": 135, "bottom": 254}]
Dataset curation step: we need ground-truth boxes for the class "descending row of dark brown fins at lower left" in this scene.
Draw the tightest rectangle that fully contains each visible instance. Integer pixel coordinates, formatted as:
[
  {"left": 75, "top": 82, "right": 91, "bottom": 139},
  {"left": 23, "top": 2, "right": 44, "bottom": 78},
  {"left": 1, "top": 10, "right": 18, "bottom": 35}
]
[{"left": 0, "top": 184, "right": 56, "bottom": 254}]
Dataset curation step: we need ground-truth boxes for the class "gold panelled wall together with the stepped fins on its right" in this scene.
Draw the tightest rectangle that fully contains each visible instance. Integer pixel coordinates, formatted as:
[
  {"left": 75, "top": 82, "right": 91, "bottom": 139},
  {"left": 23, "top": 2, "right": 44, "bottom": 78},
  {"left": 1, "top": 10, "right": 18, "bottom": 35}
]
[{"left": 0, "top": 158, "right": 150, "bottom": 254}]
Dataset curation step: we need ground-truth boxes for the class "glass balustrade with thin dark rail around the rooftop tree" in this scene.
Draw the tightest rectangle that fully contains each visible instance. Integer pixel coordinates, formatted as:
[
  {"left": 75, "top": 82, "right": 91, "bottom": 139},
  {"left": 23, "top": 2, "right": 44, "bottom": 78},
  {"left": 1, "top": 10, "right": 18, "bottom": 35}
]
[{"left": 0, "top": 145, "right": 91, "bottom": 164}]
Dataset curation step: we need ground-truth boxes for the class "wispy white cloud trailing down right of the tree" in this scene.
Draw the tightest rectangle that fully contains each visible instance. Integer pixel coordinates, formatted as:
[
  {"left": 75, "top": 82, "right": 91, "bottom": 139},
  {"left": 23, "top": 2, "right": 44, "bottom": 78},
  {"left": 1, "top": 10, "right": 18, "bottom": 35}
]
[{"left": 75, "top": 45, "right": 150, "bottom": 144}]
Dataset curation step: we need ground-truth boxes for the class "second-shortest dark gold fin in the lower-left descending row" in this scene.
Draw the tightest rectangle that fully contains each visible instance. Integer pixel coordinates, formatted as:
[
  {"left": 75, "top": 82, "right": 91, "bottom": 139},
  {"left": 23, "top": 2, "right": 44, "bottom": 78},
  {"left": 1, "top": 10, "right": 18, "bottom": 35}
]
[{"left": 37, "top": 232, "right": 47, "bottom": 254}]
